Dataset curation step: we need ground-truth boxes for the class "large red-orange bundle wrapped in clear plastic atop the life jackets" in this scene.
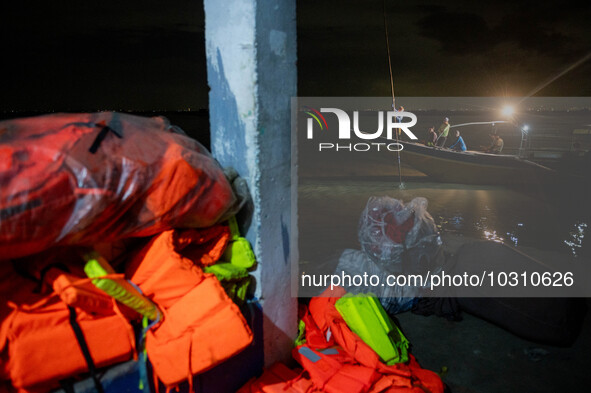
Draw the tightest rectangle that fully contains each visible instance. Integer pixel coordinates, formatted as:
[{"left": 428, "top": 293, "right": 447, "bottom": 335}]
[{"left": 0, "top": 112, "right": 235, "bottom": 259}]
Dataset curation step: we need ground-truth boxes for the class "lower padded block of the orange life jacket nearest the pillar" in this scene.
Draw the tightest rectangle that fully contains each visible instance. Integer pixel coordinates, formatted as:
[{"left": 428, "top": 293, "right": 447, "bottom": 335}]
[{"left": 146, "top": 273, "right": 252, "bottom": 388}]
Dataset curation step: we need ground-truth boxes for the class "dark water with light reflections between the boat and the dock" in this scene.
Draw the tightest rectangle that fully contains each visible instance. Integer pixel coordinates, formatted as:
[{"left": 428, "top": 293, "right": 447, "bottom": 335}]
[{"left": 298, "top": 180, "right": 590, "bottom": 257}]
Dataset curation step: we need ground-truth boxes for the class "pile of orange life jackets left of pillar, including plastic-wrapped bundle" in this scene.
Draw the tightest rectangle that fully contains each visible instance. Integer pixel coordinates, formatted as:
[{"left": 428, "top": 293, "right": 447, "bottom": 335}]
[{"left": 0, "top": 112, "right": 252, "bottom": 393}]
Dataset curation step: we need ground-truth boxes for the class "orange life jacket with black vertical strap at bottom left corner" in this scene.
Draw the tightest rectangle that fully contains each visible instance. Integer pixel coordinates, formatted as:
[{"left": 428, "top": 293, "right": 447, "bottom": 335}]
[{"left": 0, "top": 295, "right": 135, "bottom": 392}]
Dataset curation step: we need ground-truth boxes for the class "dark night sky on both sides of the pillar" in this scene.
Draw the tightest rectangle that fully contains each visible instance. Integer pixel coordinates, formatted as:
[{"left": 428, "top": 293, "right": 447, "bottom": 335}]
[{"left": 0, "top": 0, "right": 591, "bottom": 111}]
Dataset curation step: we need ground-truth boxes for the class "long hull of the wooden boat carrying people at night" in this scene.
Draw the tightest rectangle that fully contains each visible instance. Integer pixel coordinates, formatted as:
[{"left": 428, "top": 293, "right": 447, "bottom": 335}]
[{"left": 400, "top": 141, "right": 556, "bottom": 185}]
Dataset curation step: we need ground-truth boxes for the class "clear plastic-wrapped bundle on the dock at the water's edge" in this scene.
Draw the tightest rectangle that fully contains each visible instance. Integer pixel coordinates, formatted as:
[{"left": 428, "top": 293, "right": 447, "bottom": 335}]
[{"left": 335, "top": 196, "right": 443, "bottom": 314}]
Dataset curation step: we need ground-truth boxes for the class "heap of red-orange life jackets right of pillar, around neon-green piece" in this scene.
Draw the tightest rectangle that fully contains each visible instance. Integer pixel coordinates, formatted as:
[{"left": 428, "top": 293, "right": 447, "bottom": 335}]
[{"left": 293, "top": 287, "right": 443, "bottom": 393}]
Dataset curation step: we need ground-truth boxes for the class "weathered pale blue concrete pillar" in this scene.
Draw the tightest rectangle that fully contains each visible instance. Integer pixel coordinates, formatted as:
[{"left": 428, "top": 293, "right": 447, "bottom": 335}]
[{"left": 204, "top": 0, "right": 297, "bottom": 365}]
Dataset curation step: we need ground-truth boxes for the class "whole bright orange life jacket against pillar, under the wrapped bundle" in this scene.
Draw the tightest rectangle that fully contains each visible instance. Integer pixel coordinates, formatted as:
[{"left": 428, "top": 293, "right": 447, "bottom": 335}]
[{"left": 126, "top": 227, "right": 252, "bottom": 388}]
